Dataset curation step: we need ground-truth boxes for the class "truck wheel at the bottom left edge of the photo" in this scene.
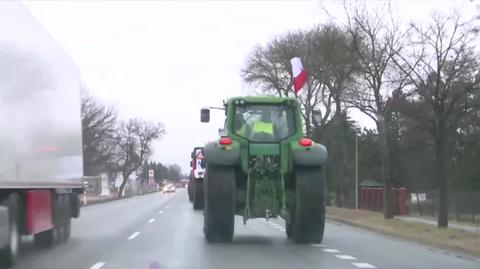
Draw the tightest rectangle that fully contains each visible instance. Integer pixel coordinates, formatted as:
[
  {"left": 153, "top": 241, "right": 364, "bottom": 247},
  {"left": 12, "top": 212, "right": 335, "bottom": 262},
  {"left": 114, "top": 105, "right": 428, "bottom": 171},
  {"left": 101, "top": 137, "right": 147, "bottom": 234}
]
[{"left": 0, "top": 193, "right": 21, "bottom": 268}]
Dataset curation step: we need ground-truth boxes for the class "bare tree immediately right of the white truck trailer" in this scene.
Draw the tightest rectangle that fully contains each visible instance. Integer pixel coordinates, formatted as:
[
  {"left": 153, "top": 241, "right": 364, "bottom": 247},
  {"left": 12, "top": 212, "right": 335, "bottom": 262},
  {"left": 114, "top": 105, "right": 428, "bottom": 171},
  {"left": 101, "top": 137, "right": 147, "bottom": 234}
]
[{"left": 82, "top": 92, "right": 117, "bottom": 175}]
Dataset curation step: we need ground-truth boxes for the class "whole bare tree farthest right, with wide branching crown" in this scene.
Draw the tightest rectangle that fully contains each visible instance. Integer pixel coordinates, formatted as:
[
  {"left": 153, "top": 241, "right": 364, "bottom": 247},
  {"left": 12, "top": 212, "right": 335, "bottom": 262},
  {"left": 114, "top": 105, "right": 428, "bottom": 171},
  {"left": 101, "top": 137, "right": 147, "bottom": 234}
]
[{"left": 395, "top": 12, "right": 480, "bottom": 227}]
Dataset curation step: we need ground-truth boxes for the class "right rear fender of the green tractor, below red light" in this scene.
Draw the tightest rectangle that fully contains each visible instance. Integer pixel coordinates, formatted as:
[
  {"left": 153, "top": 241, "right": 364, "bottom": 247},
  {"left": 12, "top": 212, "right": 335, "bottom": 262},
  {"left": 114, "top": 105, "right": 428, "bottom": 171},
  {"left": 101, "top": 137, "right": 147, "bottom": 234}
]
[{"left": 292, "top": 142, "right": 327, "bottom": 166}]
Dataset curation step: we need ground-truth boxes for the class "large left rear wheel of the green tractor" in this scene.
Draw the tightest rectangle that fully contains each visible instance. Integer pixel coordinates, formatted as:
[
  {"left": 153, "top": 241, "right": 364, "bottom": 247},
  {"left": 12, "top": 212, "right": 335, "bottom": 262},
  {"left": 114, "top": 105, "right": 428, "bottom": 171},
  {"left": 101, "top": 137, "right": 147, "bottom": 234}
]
[{"left": 203, "top": 163, "right": 235, "bottom": 243}]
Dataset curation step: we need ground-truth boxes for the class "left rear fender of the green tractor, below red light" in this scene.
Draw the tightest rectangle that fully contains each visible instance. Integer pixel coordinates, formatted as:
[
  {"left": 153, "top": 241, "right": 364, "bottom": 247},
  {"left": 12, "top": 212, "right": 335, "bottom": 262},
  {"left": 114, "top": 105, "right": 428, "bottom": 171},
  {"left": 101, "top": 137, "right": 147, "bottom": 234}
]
[{"left": 204, "top": 140, "right": 240, "bottom": 165}]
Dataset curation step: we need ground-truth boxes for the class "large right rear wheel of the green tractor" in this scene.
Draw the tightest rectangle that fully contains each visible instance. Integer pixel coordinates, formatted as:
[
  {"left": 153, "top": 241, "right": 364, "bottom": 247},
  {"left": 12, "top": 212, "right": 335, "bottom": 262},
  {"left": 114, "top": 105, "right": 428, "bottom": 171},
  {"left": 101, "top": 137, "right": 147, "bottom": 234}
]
[{"left": 292, "top": 167, "right": 326, "bottom": 244}]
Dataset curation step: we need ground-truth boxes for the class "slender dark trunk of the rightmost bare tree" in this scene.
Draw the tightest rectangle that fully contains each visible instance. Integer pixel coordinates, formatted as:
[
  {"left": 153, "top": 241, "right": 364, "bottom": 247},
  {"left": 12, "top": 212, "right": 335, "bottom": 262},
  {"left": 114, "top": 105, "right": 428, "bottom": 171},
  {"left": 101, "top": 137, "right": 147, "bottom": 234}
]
[{"left": 435, "top": 134, "right": 448, "bottom": 228}]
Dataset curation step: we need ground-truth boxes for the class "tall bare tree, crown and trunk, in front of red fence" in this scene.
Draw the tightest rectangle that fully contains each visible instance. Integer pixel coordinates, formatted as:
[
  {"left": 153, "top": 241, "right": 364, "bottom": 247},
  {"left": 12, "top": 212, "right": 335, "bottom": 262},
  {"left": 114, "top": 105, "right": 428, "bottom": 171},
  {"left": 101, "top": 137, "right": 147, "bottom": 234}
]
[{"left": 345, "top": 2, "right": 404, "bottom": 219}]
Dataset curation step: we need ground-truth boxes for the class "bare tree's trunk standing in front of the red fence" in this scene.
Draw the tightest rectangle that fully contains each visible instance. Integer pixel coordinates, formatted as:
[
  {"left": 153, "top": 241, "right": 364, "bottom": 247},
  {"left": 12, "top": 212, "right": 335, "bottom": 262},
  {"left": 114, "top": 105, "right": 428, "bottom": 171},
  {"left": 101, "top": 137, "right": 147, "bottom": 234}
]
[{"left": 377, "top": 113, "right": 394, "bottom": 219}]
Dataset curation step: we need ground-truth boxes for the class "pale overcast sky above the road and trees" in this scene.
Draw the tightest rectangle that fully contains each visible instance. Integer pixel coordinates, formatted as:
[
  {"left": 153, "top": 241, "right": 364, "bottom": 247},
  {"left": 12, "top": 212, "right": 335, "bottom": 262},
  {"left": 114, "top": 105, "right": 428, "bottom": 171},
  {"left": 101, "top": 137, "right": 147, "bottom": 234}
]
[{"left": 24, "top": 1, "right": 475, "bottom": 172}]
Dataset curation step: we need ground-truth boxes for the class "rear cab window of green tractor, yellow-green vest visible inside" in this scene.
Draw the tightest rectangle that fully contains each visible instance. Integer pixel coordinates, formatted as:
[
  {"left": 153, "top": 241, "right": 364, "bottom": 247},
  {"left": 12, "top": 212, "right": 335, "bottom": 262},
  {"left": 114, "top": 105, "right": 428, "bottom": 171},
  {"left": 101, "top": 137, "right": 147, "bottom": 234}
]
[{"left": 233, "top": 104, "right": 295, "bottom": 143}]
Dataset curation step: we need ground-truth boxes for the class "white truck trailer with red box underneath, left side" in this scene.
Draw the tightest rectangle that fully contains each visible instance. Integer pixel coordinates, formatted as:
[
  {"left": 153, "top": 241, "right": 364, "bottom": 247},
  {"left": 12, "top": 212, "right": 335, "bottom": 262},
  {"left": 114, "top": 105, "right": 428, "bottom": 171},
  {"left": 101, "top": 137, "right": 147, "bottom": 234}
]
[{"left": 0, "top": 1, "right": 83, "bottom": 267}]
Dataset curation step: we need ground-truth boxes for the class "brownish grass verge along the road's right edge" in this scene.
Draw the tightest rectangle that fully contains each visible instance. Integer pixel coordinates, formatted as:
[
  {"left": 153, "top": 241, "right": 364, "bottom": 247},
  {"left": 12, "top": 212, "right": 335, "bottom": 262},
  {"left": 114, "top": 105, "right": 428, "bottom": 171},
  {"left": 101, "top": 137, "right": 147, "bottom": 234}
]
[{"left": 327, "top": 207, "right": 480, "bottom": 257}]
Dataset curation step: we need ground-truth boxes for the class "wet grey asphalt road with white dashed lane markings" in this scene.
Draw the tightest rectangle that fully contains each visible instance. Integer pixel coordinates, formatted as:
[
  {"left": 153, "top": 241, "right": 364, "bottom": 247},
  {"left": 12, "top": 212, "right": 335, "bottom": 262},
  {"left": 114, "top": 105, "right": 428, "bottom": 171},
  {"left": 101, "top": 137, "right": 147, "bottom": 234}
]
[{"left": 11, "top": 189, "right": 480, "bottom": 269}]
